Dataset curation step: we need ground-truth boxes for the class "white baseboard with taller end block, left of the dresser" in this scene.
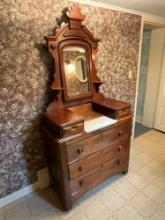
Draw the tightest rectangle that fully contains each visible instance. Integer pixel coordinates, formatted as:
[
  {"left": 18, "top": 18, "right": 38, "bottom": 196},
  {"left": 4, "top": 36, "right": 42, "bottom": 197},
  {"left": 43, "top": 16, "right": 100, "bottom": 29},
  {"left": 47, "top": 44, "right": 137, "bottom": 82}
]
[{"left": 0, "top": 168, "right": 50, "bottom": 208}]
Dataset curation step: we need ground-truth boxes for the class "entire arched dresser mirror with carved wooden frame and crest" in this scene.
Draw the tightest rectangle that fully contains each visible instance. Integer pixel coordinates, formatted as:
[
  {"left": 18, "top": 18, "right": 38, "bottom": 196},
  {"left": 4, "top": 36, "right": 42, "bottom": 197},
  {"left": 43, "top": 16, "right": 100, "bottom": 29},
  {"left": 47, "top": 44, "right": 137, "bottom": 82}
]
[{"left": 46, "top": 5, "right": 101, "bottom": 105}]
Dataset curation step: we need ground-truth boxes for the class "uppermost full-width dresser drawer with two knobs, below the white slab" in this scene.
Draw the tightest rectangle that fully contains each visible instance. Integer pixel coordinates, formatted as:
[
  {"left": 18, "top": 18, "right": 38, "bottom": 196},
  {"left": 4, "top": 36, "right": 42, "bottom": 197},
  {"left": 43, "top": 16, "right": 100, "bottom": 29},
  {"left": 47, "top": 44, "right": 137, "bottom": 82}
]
[{"left": 67, "top": 122, "right": 131, "bottom": 162}]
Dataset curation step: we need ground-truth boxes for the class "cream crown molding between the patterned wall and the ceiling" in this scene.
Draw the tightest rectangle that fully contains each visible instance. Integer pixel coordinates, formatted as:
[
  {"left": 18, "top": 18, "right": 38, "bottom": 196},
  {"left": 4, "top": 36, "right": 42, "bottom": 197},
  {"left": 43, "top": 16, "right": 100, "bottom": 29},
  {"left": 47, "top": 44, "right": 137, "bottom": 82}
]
[{"left": 68, "top": 0, "right": 165, "bottom": 26}]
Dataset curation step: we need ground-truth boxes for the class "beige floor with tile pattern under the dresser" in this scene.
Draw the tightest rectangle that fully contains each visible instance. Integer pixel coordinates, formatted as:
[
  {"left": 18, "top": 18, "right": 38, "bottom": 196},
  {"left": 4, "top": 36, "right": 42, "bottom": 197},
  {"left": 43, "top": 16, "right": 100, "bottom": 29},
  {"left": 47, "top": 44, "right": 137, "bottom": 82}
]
[{"left": 0, "top": 130, "right": 165, "bottom": 220}]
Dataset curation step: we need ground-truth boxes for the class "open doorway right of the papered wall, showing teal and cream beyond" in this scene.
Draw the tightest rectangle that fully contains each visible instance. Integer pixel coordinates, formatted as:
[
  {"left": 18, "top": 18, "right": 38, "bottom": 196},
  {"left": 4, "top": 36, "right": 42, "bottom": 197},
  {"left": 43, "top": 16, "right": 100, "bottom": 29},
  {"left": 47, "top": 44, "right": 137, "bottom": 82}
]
[{"left": 134, "top": 24, "right": 165, "bottom": 137}]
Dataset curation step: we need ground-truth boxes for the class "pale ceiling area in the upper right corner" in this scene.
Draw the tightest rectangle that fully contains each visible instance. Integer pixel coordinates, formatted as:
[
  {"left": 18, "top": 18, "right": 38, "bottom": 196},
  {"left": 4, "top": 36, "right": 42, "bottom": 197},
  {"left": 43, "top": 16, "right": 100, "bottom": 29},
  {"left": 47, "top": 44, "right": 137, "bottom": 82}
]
[{"left": 94, "top": 0, "right": 165, "bottom": 17}]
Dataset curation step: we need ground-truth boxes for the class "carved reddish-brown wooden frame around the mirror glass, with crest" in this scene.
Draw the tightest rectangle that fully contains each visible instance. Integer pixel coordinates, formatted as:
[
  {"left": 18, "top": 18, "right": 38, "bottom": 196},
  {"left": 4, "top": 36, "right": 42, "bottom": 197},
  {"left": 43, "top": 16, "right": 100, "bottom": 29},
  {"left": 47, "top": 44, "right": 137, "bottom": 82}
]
[{"left": 45, "top": 4, "right": 101, "bottom": 108}]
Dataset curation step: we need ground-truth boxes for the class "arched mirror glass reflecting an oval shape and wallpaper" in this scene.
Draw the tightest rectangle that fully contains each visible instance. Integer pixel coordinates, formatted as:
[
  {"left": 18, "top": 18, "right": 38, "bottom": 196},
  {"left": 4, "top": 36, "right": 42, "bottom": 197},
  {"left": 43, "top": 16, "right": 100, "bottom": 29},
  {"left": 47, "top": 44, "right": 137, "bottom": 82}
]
[{"left": 63, "top": 46, "right": 89, "bottom": 96}]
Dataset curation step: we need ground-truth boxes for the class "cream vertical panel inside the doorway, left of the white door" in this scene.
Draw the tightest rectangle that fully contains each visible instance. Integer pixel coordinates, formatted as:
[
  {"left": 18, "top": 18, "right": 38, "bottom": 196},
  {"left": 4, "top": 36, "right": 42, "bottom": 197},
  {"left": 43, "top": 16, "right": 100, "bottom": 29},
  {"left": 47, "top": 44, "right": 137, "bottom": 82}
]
[{"left": 142, "top": 28, "right": 165, "bottom": 128}]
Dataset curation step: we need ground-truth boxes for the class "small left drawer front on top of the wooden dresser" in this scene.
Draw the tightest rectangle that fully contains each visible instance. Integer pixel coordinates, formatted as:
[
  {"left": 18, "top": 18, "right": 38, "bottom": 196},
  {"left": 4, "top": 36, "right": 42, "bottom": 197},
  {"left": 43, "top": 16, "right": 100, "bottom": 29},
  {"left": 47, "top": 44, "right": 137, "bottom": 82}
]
[{"left": 63, "top": 122, "right": 84, "bottom": 136}]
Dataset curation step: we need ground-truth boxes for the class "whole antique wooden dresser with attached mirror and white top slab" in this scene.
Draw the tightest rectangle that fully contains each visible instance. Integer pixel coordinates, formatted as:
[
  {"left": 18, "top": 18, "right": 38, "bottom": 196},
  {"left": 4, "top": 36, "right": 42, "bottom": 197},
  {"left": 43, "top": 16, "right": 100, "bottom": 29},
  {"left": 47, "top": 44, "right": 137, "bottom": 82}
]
[{"left": 43, "top": 5, "right": 132, "bottom": 210}]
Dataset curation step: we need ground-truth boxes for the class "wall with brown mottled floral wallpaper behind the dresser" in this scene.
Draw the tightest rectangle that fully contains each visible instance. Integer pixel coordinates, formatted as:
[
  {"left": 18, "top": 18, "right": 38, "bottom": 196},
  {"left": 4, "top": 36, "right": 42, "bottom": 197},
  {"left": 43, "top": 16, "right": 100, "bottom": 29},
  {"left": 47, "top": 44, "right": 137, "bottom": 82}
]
[{"left": 0, "top": 0, "right": 141, "bottom": 197}]
